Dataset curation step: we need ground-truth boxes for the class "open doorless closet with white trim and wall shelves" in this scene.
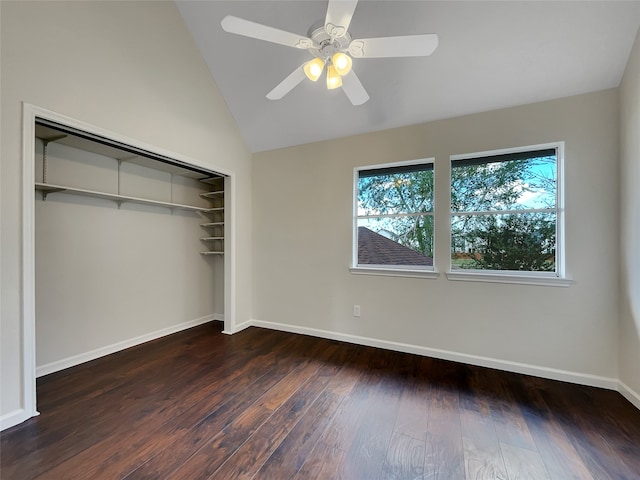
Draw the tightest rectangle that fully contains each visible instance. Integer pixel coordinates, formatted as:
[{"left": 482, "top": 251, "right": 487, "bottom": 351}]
[{"left": 23, "top": 106, "right": 233, "bottom": 418}]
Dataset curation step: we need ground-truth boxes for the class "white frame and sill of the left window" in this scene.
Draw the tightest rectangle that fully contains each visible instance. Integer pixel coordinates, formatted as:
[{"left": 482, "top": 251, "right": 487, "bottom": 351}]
[{"left": 349, "top": 157, "right": 439, "bottom": 278}]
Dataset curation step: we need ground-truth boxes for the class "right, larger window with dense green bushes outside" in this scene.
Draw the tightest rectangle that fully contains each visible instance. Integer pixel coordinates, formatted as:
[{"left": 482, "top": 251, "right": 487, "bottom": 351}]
[{"left": 451, "top": 144, "right": 563, "bottom": 277}]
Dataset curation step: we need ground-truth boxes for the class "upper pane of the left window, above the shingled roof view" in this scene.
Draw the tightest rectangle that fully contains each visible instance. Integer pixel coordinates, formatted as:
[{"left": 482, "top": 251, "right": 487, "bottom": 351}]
[{"left": 358, "top": 165, "right": 433, "bottom": 216}]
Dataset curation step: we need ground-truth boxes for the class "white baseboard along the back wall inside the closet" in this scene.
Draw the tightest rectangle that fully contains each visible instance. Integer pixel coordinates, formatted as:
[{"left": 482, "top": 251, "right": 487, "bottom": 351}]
[{"left": 36, "top": 313, "right": 224, "bottom": 378}]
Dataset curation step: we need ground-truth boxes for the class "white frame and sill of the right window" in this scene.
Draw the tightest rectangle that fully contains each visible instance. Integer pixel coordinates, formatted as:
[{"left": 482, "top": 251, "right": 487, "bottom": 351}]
[{"left": 446, "top": 142, "right": 573, "bottom": 287}]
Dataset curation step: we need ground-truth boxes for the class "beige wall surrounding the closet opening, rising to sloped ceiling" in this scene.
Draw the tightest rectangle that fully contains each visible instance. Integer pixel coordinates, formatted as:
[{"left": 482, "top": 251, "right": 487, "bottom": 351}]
[{"left": 0, "top": 1, "right": 252, "bottom": 424}]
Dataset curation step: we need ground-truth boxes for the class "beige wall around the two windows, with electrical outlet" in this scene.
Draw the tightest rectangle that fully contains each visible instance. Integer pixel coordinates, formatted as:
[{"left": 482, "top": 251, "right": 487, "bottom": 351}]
[{"left": 253, "top": 90, "right": 619, "bottom": 383}]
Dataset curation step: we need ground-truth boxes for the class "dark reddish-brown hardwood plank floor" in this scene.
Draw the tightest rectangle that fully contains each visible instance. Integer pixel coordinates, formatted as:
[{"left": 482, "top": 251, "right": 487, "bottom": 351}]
[{"left": 0, "top": 323, "right": 640, "bottom": 480}]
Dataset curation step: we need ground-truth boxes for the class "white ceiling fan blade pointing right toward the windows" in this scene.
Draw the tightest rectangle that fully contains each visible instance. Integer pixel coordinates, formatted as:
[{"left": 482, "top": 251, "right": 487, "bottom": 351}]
[{"left": 349, "top": 34, "right": 438, "bottom": 58}]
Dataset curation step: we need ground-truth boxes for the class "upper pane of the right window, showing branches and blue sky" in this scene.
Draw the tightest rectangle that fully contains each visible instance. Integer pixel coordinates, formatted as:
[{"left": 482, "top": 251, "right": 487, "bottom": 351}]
[{"left": 451, "top": 154, "right": 556, "bottom": 212}]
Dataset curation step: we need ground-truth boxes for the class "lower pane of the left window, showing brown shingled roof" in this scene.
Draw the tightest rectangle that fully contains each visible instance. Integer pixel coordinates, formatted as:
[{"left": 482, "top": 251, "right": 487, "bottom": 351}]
[{"left": 358, "top": 215, "right": 433, "bottom": 266}]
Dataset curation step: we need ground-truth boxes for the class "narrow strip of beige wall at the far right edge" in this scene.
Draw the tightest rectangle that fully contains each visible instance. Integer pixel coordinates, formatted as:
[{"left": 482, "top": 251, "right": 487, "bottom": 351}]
[{"left": 620, "top": 31, "right": 640, "bottom": 400}]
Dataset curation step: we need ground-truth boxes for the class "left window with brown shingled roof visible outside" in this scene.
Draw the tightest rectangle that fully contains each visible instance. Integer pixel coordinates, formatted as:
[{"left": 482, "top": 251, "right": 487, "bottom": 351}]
[{"left": 354, "top": 160, "right": 434, "bottom": 271}]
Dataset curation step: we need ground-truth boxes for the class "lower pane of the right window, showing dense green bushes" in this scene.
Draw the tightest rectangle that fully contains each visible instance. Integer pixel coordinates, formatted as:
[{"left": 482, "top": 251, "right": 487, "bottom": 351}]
[{"left": 451, "top": 213, "right": 556, "bottom": 272}]
